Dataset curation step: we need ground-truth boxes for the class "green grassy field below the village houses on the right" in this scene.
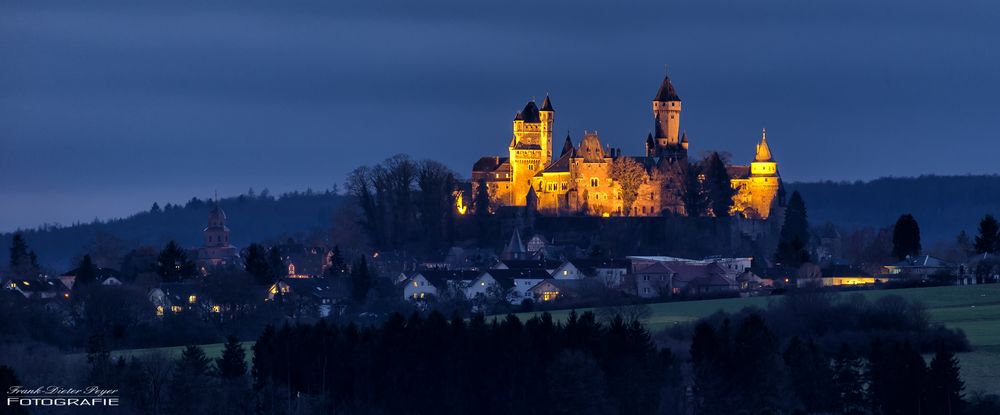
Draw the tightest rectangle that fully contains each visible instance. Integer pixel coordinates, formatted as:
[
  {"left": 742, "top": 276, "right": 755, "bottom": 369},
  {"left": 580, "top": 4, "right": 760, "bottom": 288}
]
[{"left": 518, "top": 284, "right": 1000, "bottom": 394}]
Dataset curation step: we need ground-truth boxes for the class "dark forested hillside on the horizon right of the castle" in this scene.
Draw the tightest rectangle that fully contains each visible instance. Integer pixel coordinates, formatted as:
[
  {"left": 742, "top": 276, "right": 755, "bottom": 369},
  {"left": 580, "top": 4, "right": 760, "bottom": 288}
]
[{"left": 786, "top": 175, "right": 1000, "bottom": 246}]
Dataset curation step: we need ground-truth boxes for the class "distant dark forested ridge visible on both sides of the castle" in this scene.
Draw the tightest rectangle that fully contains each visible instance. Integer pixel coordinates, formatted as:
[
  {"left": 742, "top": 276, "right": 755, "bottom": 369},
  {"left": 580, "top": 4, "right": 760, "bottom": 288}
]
[{"left": 0, "top": 176, "right": 1000, "bottom": 269}]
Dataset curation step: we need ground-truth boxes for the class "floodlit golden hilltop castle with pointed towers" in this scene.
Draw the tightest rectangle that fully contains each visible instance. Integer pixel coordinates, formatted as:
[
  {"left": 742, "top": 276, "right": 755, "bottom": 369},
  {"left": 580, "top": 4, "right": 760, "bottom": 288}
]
[{"left": 472, "top": 71, "right": 781, "bottom": 219}]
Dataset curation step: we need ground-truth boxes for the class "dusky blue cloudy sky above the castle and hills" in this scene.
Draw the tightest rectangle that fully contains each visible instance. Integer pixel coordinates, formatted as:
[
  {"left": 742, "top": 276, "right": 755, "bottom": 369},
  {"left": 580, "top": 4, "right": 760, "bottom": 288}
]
[{"left": 0, "top": 0, "right": 1000, "bottom": 231}]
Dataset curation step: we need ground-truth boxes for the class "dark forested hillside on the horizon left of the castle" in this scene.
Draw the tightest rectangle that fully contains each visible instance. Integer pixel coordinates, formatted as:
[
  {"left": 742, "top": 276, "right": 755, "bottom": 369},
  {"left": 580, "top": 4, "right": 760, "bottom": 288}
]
[{"left": 0, "top": 191, "right": 347, "bottom": 270}]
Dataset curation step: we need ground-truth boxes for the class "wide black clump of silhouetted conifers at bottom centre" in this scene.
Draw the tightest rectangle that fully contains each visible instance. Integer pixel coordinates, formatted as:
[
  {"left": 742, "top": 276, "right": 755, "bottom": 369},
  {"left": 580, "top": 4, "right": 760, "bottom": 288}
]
[{"left": 253, "top": 312, "right": 677, "bottom": 414}]
